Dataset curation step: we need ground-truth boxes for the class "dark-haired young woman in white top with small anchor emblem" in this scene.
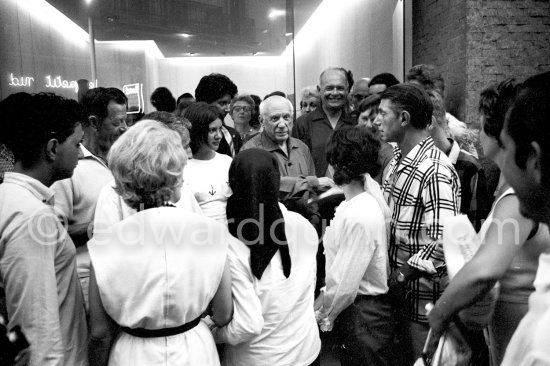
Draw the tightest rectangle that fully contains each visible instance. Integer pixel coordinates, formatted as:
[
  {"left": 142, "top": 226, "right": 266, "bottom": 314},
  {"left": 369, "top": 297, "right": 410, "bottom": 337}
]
[{"left": 183, "top": 103, "right": 231, "bottom": 225}]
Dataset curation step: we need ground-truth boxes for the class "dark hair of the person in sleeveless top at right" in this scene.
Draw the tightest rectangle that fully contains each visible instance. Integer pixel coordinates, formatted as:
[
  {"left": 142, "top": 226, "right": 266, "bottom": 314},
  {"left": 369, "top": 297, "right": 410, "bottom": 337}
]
[{"left": 478, "top": 79, "right": 518, "bottom": 145}]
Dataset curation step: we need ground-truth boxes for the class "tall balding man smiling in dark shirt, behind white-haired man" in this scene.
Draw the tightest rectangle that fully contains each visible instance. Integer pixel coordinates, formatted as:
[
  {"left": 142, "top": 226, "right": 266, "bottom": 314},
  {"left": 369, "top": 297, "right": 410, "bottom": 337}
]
[{"left": 292, "top": 67, "right": 357, "bottom": 177}]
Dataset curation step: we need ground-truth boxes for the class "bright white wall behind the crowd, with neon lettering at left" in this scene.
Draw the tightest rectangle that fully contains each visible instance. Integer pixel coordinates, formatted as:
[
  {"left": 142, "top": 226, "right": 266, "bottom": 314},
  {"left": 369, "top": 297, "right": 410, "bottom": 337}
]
[{"left": 0, "top": 0, "right": 403, "bottom": 112}]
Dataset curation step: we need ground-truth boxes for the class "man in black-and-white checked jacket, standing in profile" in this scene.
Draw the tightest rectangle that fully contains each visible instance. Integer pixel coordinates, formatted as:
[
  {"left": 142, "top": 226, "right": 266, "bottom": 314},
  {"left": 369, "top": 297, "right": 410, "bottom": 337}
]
[{"left": 374, "top": 84, "right": 460, "bottom": 365}]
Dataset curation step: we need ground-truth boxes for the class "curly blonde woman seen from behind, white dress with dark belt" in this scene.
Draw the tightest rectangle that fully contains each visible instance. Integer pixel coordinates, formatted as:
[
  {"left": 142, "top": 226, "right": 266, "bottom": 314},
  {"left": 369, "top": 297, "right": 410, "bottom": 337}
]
[{"left": 88, "top": 120, "right": 233, "bottom": 366}]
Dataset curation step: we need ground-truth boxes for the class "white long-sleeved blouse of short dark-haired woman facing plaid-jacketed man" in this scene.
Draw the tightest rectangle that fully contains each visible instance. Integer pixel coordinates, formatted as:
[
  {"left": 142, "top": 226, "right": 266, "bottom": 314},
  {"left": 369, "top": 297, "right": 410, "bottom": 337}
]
[{"left": 321, "top": 192, "right": 388, "bottom": 322}]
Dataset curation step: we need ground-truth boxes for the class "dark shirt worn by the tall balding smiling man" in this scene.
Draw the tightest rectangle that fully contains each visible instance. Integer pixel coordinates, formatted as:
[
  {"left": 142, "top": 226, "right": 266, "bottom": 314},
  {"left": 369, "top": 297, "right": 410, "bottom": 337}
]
[{"left": 292, "top": 107, "right": 357, "bottom": 177}]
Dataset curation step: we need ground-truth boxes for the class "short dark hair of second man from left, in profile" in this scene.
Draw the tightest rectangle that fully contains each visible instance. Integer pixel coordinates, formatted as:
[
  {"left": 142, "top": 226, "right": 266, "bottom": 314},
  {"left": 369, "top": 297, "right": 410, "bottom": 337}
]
[{"left": 82, "top": 87, "right": 128, "bottom": 126}]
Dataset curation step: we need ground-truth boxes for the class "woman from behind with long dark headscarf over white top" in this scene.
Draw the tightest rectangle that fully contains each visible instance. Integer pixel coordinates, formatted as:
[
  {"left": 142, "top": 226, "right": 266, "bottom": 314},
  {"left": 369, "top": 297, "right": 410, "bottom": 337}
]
[{"left": 218, "top": 149, "right": 321, "bottom": 366}]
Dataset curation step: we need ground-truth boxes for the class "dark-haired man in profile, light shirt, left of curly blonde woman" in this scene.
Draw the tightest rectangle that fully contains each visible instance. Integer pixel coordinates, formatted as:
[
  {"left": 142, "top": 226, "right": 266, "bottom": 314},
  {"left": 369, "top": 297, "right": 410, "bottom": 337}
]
[{"left": 52, "top": 88, "right": 128, "bottom": 304}]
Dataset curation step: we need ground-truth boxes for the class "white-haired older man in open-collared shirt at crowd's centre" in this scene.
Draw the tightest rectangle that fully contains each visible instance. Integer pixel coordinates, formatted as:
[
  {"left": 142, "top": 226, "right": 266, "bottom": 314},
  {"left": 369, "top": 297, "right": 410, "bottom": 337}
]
[{"left": 241, "top": 96, "right": 334, "bottom": 223}]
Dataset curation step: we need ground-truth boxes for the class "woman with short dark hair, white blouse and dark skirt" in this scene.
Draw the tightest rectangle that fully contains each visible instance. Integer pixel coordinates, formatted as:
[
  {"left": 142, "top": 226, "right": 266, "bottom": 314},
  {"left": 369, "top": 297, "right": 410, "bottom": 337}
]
[{"left": 316, "top": 127, "right": 394, "bottom": 366}]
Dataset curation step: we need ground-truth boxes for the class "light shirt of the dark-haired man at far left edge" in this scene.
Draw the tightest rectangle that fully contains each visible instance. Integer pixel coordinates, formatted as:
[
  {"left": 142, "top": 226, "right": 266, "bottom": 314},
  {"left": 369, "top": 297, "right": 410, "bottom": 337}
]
[{"left": 0, "top": 173, "right": 88, "bottom": 366}]
